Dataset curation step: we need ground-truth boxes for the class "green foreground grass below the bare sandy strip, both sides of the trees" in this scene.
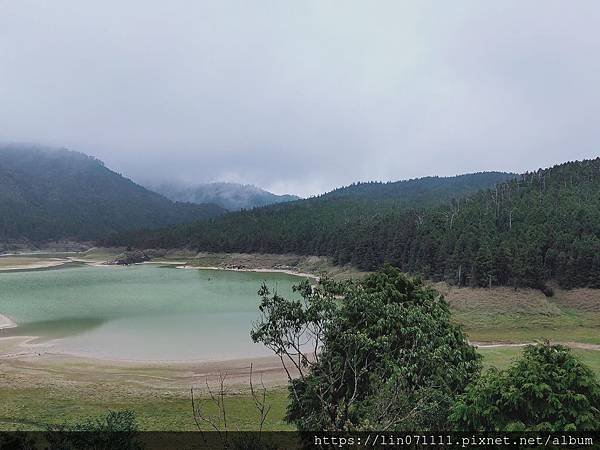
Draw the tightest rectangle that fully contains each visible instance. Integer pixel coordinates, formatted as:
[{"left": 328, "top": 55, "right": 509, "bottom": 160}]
[{"left": 0, "top": 347, "right": 600, "bottom": 431}]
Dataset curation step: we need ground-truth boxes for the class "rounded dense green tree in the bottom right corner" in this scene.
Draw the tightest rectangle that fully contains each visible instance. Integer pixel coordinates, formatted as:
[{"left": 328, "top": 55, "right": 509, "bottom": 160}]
[{"left": 451, "top": 344, "right": 600, "bottom": 431}]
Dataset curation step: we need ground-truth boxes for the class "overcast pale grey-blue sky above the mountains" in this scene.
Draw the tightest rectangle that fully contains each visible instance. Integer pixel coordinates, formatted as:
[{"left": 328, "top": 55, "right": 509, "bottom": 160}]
[{"left": 0, "top": 0, "right": 600, "bottom": 195}]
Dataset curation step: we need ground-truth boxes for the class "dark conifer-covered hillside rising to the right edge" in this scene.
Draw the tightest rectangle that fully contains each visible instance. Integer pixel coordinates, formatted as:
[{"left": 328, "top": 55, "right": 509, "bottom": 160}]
[{"left": 414, "top": 158, "right": 600, "bottom": 288}]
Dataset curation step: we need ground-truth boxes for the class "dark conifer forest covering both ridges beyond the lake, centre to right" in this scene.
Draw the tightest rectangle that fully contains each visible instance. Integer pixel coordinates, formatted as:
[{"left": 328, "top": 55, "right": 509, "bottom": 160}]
[{"left": 104, "top": 159, "right": 600, "bottom": 288}]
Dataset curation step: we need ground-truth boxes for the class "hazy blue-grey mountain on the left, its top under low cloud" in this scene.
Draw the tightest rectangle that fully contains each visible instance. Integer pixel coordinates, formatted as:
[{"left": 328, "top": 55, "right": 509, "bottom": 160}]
[{"left": 0, "top": 145, "right": 225, "bottom": 241}]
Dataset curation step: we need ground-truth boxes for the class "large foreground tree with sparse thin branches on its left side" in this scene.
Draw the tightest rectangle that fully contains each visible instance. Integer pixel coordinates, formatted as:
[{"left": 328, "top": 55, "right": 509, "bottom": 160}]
[{"left": 252, "top": 266, "right": 480, "bottom": 431}]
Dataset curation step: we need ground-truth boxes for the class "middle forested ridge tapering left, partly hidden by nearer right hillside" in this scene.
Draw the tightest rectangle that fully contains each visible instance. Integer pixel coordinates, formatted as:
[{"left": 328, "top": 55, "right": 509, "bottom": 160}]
[{"left": 104, "top": 172, "right": 514, "bottom": 269}]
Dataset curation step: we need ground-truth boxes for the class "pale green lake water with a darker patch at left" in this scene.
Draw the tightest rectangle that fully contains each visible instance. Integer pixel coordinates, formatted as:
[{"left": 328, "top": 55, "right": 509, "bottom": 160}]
[{"left": 0, "top": 265, "right": 301, "bottom": 361}]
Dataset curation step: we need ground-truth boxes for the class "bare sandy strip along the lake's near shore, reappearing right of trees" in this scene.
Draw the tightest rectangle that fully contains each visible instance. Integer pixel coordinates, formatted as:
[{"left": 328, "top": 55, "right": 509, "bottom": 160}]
[{"left": 0, "top": 336, "right": 600, "bottom": 392}]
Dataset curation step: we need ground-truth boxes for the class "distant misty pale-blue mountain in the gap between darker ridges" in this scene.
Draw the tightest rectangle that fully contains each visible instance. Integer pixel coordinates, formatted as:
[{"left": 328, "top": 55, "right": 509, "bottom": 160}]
[{"left": 152, "top": 183, "right": 300, "bottom": 211}]
